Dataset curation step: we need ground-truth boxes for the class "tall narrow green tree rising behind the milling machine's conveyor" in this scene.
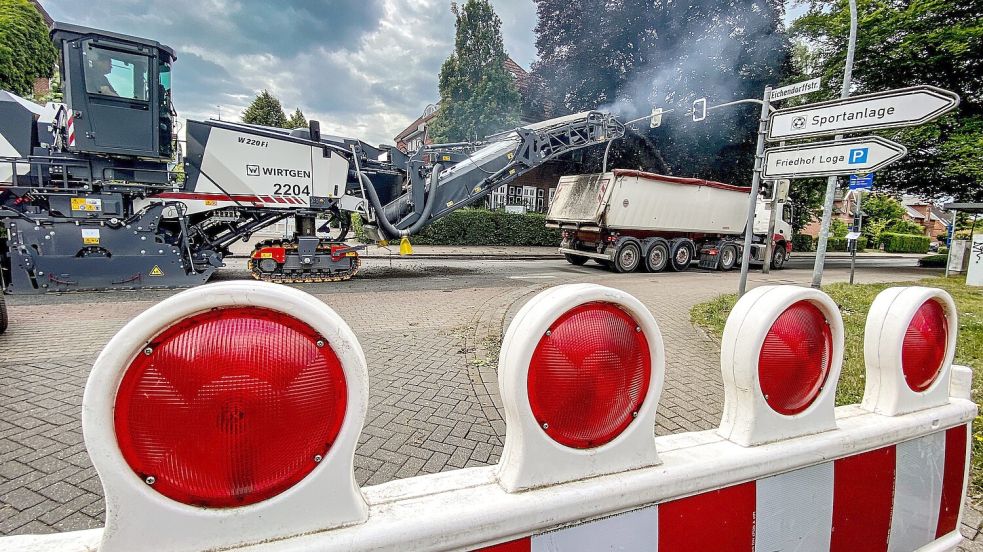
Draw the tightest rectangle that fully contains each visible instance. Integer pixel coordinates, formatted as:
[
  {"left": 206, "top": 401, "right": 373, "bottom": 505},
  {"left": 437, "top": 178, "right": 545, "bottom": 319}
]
[{"left": 430, "top": 0, "right": 521, "bottom": 142}]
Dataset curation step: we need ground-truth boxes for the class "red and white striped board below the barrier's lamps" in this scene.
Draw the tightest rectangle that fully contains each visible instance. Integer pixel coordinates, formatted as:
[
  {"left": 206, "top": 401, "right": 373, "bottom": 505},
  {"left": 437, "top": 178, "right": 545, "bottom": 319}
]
[{"left": 480, "top": 425, "right": 968, "bottom": 552}]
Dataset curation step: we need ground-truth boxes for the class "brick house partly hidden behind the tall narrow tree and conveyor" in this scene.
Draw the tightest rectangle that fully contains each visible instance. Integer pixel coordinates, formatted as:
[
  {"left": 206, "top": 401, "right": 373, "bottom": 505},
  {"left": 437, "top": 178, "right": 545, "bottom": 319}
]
[{"left": 393, "top": 58, "right": 562, "bottom": 213}]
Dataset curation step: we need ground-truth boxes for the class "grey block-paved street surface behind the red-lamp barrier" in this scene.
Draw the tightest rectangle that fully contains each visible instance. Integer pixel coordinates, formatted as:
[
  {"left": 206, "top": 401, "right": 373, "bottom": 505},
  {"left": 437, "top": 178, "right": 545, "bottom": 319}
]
[{"left": 0, "top": 257, "right": 979, "bottom": 548}]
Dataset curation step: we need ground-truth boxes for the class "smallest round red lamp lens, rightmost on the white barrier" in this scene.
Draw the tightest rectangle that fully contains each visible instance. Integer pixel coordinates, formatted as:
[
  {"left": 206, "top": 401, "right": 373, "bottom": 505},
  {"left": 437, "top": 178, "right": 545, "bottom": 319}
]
[{"left": 901, "top": 299, "right": 949, "bottom": 391}]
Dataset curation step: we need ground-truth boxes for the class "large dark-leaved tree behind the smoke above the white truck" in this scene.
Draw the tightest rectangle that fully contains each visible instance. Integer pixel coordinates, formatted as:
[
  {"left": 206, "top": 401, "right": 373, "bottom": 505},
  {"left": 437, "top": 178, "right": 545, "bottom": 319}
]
[{"left": 533, "top": 0, "right": 791, "bottom": 183}]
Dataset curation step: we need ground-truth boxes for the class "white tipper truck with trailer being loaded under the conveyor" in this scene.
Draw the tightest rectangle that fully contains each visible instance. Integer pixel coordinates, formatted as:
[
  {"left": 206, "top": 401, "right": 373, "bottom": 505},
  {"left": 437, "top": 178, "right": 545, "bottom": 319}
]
[{"left": 546, "top": 169, "right": 792, "bottom": 272}]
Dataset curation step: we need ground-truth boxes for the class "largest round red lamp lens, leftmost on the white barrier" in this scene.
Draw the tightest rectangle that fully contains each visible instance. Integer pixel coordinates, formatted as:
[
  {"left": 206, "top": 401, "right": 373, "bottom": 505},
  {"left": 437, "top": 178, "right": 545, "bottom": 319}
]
[{"left": 114, "top": 308, "right": 348, "bottom": 508}]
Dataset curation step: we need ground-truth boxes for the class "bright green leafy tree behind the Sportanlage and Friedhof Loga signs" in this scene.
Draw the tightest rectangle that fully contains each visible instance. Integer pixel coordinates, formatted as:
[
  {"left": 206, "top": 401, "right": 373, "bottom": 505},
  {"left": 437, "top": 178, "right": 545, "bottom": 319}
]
[{"left": 791, "top": 0, "right": 983, "bottom": 201}]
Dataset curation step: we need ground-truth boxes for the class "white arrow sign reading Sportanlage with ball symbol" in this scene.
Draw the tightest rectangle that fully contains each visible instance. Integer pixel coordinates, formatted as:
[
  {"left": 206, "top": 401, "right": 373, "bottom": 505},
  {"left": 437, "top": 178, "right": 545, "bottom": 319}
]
[{"left": 768, "top": 86, "right": 959, "bottom": 142}]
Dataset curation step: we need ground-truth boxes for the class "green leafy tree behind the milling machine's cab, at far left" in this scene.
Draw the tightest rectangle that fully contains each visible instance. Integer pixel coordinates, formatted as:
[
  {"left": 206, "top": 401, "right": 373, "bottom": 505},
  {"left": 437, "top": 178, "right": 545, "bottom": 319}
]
[{"left": 0, "top": 0, "right": 57, "bottom": 96}]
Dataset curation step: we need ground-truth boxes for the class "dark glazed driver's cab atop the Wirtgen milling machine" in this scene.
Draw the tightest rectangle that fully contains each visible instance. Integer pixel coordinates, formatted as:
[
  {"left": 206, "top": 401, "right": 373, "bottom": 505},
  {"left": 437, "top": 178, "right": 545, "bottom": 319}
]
[{"left": 51, "top": 23, "right": 176, "bottom": 159}]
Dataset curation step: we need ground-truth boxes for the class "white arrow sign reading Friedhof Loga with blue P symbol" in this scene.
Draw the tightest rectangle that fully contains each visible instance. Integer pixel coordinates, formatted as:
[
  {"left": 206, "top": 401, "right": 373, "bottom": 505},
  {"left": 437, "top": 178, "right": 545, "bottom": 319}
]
[{"left": 763, "top": 136, "right": 908, "bottom": 179}]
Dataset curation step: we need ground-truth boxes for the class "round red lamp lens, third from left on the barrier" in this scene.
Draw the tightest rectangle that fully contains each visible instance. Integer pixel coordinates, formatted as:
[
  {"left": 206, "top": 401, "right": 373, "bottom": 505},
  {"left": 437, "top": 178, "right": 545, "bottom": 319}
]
[{"left": 758, "top": 301, "right": 833, "bottom": 416}]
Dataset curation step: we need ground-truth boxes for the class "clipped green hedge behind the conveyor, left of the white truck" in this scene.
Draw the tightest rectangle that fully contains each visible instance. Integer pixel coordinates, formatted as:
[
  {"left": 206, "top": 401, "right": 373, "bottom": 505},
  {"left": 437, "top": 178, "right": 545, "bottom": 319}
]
[{"left": 352, "top": 209, "right": 561, "bottom": 247}]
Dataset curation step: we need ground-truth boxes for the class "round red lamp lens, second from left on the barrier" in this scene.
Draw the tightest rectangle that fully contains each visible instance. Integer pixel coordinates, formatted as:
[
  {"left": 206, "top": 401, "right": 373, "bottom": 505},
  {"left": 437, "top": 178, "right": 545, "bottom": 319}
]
[{"left": 526, "top": 302, "right": 652, "bottom": 449}]
